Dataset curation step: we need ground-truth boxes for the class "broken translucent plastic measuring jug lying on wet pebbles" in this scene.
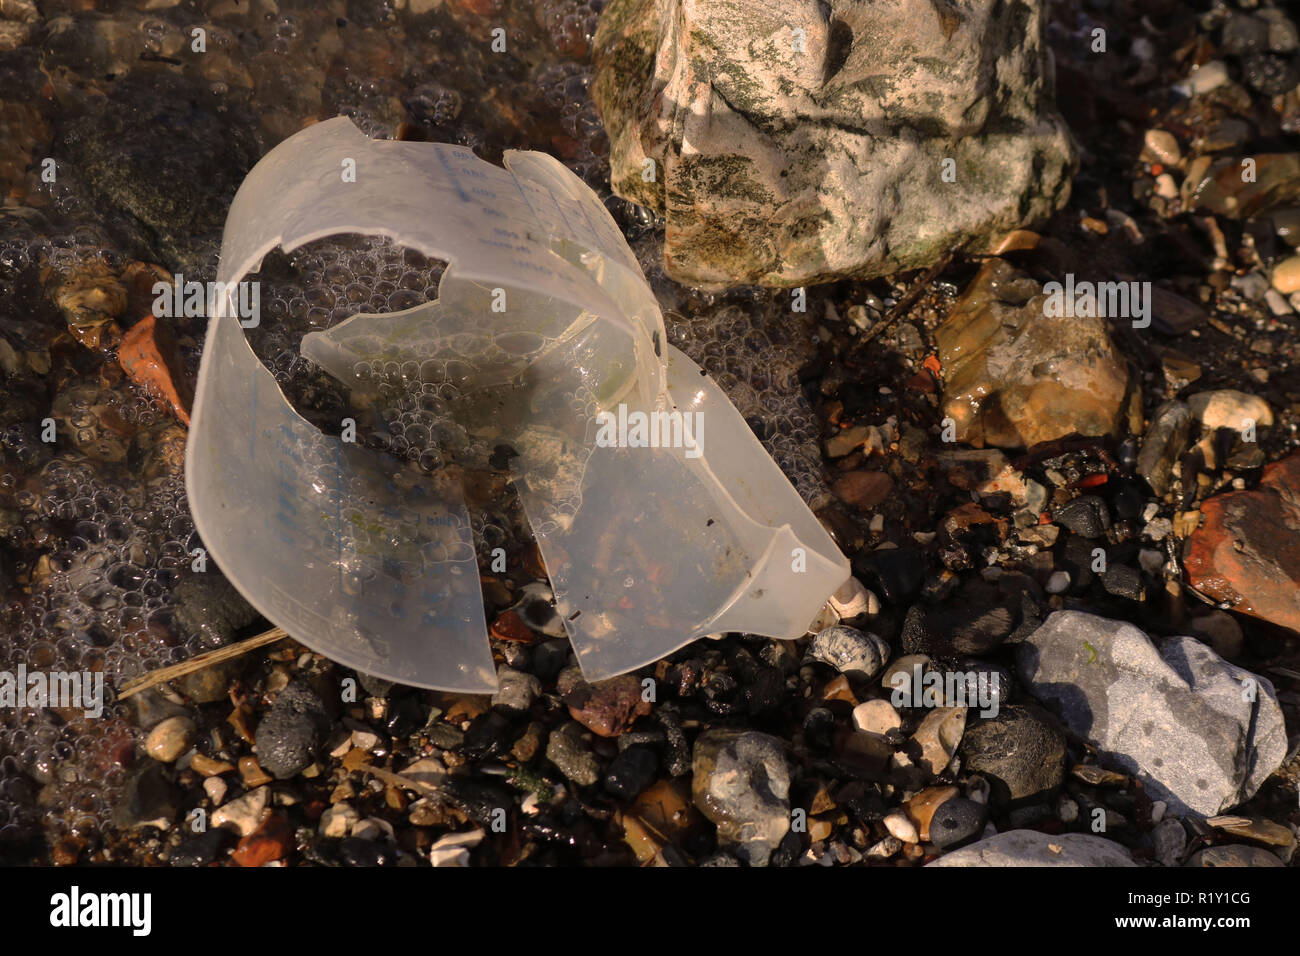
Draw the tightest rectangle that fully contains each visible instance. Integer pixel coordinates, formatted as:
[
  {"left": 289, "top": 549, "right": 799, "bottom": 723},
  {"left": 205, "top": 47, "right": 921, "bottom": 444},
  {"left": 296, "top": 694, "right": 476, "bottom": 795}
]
[{"left": 186, "top": 117, "right": 849, "bottom": 693}]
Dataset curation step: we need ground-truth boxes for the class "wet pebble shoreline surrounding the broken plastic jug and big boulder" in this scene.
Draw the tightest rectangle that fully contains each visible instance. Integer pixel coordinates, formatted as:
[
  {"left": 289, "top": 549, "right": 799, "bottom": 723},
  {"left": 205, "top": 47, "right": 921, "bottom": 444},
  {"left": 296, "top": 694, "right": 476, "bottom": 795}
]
[{"left": 0, "top": 0, "right": 1300, "bottom": 866}]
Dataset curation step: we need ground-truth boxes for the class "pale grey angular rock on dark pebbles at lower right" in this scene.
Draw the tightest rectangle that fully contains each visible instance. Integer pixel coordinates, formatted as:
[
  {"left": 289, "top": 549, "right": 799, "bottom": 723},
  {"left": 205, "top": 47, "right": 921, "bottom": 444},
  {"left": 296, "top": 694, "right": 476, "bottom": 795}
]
[{"left": 1017, "top": 611, "right": 1287, "bottom": 816}]
